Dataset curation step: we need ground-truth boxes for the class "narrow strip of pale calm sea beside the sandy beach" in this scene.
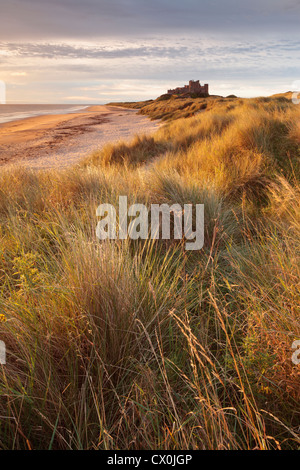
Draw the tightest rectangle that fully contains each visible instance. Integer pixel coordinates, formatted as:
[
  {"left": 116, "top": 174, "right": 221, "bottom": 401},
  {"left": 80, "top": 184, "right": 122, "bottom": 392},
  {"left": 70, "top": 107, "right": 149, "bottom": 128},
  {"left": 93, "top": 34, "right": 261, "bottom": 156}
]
[{"left": 0, "top": 104, "right": 91, "bottom": 124}]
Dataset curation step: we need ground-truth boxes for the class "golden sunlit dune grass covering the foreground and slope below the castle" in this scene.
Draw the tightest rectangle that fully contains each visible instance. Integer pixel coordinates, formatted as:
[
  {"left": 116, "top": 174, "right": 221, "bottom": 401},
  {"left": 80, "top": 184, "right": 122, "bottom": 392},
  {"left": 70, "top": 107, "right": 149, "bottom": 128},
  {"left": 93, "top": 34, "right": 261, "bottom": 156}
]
[{"left": 0, "top": 97, "right": 300, "bottom": 449}]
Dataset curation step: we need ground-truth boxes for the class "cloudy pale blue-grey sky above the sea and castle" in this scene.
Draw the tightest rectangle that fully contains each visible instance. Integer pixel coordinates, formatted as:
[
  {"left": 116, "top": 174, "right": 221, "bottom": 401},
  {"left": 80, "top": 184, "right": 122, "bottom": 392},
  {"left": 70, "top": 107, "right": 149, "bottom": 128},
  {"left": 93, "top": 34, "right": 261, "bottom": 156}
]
[{"left": 0, "top": 0, "right": 300, "bottom": 104}]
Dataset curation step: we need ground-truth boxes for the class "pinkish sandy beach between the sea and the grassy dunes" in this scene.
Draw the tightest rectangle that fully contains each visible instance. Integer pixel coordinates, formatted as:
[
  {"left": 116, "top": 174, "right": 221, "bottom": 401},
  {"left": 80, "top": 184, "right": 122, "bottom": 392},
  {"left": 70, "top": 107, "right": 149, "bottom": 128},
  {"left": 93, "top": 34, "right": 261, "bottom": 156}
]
[{"left": 0, "top": 105, "right": 160, "bottom": 169}]
